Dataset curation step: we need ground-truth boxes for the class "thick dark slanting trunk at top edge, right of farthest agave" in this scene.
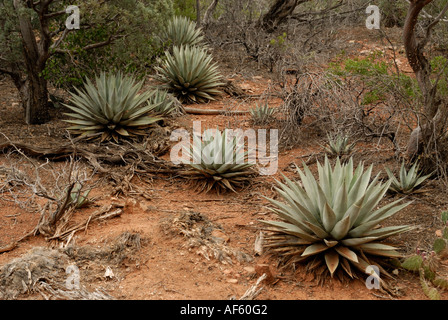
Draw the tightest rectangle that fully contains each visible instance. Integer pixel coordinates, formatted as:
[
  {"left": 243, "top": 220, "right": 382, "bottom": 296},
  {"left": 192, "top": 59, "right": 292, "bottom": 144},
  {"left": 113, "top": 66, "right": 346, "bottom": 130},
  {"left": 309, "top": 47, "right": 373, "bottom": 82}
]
[{"left": 258, "top": 0, "right": 310, "bottom": 32}]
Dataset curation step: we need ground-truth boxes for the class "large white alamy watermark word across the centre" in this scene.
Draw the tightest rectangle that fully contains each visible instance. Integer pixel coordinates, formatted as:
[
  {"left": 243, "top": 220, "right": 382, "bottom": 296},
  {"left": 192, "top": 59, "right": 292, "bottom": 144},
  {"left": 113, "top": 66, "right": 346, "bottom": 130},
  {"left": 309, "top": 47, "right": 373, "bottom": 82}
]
[{"left": 170, "top": 121, "right": 278, "bottom": 175}]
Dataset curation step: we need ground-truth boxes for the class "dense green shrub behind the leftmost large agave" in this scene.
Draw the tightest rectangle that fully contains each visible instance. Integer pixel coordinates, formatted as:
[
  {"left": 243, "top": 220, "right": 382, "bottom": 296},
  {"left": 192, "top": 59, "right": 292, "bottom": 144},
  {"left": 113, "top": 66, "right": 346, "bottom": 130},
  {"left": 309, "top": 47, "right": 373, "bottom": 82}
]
[{"left": 43, "top": 0, "right": 173, "bottom": 89}]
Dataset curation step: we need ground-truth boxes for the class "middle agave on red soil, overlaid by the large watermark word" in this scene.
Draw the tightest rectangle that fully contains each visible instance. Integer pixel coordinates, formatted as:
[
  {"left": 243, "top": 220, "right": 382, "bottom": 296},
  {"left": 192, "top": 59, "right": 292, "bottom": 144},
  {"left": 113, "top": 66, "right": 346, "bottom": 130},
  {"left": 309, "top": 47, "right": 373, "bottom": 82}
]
[{"left": 183, "top": 130, "right": 255, "bottom": 193}]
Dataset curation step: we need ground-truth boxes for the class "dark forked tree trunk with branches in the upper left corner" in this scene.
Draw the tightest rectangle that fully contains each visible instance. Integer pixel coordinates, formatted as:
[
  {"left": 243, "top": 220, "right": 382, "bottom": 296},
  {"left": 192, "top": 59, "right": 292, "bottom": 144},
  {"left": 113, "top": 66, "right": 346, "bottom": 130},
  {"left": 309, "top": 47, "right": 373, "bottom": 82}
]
[{"left": 0, "top": 0, "right": 124, "bottom": 124}]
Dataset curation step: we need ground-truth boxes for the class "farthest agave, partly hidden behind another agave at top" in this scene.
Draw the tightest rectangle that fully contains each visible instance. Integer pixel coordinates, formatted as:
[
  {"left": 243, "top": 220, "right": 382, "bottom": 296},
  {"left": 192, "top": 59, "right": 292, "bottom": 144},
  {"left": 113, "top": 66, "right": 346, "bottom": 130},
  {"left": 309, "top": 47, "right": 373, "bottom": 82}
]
[{"left": 162, "top": 16, "right": 205, "bottom": 46}]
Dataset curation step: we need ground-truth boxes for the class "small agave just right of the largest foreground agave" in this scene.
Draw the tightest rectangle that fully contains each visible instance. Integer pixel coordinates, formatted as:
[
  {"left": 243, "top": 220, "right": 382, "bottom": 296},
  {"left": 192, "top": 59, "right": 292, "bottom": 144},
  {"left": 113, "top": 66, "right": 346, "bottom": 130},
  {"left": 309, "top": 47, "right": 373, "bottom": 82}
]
[{"left": 386, "top": 161, "right": 432, "bottom": 194}]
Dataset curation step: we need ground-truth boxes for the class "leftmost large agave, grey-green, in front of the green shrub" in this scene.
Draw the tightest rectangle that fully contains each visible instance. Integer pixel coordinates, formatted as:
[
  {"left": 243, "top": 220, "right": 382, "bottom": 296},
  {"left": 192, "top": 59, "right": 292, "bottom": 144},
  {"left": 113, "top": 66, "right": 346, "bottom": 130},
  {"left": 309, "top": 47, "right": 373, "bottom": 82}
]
[{"left": 65, "top": 72, "right": 161, "bottom": 142}]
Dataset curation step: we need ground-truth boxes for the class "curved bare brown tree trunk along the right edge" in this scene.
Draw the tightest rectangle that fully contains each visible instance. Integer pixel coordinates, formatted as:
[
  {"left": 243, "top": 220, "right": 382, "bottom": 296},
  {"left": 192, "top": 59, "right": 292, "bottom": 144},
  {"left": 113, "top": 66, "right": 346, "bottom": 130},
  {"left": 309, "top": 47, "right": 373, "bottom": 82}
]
[{"left": 403, "top": 0, "right": 448, "bottom": 158}]
